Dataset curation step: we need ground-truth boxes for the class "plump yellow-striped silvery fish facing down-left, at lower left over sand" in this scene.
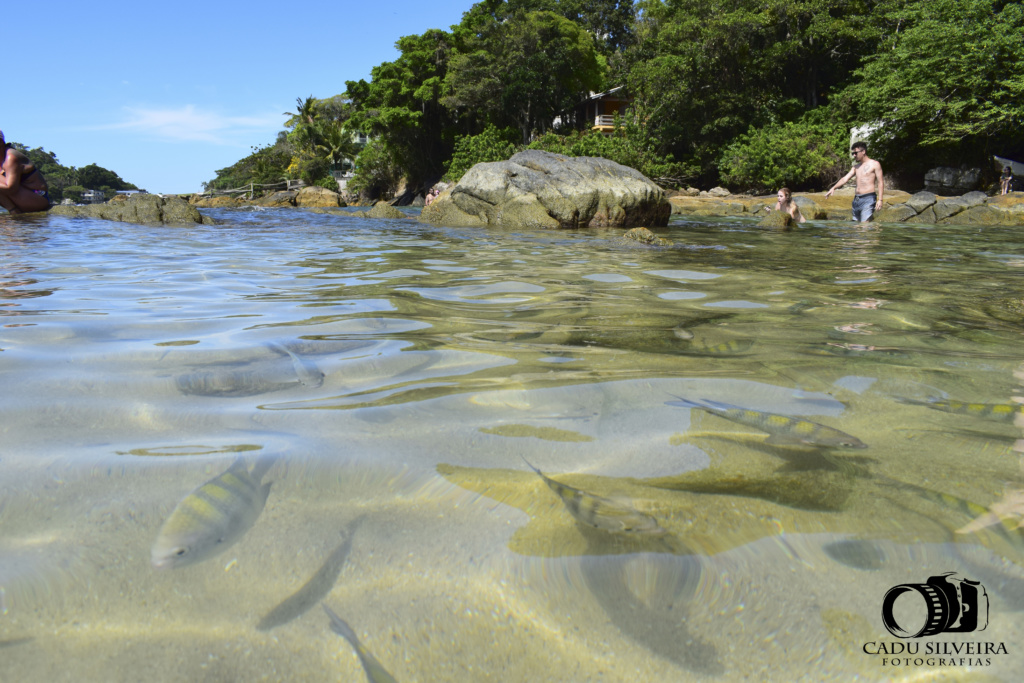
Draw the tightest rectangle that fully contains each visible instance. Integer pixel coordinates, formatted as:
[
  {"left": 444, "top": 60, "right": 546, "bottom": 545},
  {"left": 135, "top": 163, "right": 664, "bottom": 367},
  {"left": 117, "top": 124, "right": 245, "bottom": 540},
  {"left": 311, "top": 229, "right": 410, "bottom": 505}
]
[{"left": 151, "top": 457, "right": 276, "bottom": 569}]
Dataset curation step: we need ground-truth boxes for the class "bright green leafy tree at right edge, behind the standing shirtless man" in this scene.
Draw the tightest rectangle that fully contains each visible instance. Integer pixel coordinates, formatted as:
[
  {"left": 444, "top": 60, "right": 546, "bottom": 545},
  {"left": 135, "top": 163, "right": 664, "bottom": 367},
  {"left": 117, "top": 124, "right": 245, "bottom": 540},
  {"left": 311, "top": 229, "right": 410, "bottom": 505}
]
[{"left": 843, "top": 0, "right": 1024, "bottom": 172}]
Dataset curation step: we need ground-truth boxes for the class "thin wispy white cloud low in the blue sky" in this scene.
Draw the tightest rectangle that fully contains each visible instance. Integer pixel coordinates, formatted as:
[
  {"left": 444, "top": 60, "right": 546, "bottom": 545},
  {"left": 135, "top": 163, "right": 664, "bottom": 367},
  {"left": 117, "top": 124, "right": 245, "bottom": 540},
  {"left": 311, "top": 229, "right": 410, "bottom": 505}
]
[{"left": 97, "top": 104, "right": 285, "bottom": 144}]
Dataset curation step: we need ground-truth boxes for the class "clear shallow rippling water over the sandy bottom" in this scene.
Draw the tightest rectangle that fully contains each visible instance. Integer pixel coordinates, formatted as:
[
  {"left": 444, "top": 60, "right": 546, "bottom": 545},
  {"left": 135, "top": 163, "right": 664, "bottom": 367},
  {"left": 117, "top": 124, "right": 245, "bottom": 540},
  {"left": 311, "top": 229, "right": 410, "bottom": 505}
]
[{"left": 0, "top": 210, "right": 1024, "bottom": 681}]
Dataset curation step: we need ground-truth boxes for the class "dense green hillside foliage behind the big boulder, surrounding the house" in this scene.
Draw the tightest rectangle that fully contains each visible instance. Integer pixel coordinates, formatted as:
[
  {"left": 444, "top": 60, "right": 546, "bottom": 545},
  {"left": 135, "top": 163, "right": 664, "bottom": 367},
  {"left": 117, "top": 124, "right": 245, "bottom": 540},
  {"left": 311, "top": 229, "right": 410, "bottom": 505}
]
[{"left": 207, "top": 0, "right": 1024, "bottom": 197}]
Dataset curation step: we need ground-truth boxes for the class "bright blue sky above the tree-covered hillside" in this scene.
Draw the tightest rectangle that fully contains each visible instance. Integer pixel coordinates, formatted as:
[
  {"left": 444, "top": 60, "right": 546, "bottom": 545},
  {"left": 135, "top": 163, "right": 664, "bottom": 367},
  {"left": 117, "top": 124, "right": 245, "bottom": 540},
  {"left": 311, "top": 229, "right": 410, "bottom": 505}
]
[{"left": 7, "top": 0, "right": 473, "bottom": 193}]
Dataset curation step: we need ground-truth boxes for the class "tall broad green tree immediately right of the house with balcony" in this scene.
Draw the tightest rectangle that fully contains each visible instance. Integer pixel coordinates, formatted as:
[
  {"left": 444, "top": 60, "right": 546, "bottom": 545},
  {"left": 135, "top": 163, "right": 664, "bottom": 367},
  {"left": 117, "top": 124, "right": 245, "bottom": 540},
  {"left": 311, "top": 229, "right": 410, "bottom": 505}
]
[{"left": 621, "top": 0, "right": 889, "bottom": 183}]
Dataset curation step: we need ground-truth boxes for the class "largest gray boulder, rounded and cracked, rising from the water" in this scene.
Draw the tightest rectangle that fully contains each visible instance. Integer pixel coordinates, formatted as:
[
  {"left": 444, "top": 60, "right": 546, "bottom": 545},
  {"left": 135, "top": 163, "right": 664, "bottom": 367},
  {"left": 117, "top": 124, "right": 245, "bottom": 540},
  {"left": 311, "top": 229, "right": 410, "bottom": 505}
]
[{"left": 420, "top": 150, "right": 672, "bottom": 228}]
